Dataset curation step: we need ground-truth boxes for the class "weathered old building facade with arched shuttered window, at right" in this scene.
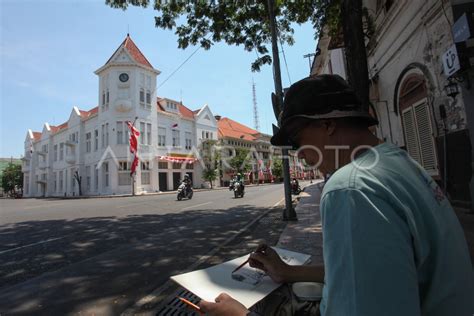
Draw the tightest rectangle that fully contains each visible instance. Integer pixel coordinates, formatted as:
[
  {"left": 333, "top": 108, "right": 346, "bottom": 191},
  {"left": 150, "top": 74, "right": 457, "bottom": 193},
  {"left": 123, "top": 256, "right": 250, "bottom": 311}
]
[{"left": 312, "top": 0, "right": 474, "bottom": 206}]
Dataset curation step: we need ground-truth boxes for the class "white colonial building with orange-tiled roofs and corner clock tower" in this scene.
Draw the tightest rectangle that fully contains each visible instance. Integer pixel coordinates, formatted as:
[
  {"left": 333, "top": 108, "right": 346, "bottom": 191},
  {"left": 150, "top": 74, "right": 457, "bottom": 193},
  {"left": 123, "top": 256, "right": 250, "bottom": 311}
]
[{"left": 23, "top": 35, "right": 217, "bottom": 197}]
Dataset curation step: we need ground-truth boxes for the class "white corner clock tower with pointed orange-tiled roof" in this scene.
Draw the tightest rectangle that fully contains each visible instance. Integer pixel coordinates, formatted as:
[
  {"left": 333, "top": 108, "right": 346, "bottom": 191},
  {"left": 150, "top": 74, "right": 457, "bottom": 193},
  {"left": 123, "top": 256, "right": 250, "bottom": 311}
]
[{"left": 95, "top": 34, "right": 160, "bottom": 193}]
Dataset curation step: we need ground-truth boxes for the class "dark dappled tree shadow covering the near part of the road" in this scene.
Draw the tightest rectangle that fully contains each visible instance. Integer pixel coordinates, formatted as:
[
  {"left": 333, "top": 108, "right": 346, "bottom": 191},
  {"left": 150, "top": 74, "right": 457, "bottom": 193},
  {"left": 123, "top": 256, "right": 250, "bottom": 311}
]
[{"left": 0, "top": 205, "right": 282, "bottom": 315}]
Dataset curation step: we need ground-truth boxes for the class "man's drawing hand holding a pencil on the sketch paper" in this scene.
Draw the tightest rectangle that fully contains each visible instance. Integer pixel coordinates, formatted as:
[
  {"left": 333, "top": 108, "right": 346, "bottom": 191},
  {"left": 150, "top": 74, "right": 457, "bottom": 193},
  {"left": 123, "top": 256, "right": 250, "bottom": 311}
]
[{"left": 249, "top": 245, "right": 289, "bottom": 283}]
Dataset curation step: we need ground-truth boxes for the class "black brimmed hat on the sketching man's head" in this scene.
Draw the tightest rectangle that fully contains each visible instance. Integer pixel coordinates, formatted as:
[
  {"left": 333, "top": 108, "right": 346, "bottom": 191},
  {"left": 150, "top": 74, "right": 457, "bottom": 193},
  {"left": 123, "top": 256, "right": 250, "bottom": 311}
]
[{"left": 271, "top": 75, "right": 378, "bottom": 146}]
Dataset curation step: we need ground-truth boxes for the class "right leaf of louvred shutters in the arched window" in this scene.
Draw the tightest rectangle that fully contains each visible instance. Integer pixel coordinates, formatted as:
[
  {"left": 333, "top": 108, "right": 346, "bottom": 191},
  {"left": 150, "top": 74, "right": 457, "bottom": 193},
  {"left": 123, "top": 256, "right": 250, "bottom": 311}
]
[{"left": 413, "top": 101, "right": 437, "bottom": 174}]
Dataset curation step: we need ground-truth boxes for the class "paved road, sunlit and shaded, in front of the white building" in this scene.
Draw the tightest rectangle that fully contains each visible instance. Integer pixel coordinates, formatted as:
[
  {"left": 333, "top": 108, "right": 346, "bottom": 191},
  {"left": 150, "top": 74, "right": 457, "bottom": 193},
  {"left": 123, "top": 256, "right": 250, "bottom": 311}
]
[{"left": 0, "top": 185, "right": 283, "bottom": 315}]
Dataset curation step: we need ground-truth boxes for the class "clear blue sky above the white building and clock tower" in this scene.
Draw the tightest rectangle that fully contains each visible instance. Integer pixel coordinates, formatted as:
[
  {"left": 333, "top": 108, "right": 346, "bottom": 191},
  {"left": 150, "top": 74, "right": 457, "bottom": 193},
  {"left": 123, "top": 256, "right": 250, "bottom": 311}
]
[{"left": 0, "top": 0, "right": 316, "bottom": 157}]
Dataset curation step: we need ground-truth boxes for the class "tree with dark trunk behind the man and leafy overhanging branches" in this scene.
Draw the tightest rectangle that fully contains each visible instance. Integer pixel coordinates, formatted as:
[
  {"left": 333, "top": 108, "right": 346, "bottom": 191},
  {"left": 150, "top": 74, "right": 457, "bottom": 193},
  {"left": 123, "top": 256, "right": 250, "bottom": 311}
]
[{"left": 105, "top": 0, "right": 369, "bottom": 110}]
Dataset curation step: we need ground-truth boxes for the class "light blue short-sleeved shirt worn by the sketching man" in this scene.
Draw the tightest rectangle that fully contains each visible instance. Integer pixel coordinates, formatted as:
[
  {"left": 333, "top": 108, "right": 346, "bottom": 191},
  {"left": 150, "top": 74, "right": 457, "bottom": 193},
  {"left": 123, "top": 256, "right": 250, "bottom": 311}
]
[{"left": 320, "top": 144, "right": 474, "bottom": 316}]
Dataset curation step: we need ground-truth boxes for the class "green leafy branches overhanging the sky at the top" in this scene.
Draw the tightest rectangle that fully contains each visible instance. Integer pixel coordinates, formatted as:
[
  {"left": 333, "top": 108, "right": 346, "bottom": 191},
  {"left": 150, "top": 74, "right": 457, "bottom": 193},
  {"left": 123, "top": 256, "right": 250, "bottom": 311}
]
[{"left": 105, "top": 0, "right": 340, "bottom": 71}]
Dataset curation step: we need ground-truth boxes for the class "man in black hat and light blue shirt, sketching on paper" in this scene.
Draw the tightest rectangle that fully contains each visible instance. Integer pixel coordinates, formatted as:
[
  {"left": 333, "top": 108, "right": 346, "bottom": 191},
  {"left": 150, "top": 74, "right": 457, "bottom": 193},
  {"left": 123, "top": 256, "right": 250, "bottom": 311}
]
[{"left": 200, "top": 75, "right": 474, "bottom": 316}]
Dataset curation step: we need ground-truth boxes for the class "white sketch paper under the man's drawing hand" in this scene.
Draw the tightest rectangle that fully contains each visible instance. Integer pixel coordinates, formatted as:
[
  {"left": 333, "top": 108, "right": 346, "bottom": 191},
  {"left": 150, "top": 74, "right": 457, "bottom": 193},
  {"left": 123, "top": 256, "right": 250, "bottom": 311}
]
[{"left": 171, "top": 247, "right": 310, "bottom": 308}]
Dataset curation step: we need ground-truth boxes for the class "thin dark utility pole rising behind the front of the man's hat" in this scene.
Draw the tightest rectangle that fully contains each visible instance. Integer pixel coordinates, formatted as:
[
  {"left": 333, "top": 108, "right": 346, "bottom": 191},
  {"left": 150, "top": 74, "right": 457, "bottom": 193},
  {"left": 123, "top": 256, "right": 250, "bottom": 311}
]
[{"left": 268, "top": 0, "right": 297, "bottom": 221}]
